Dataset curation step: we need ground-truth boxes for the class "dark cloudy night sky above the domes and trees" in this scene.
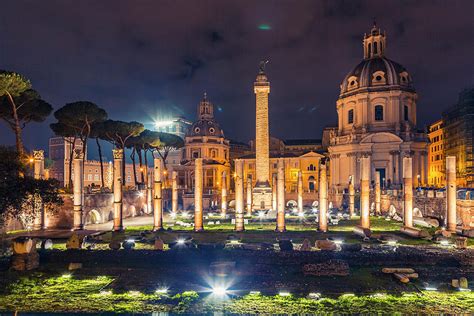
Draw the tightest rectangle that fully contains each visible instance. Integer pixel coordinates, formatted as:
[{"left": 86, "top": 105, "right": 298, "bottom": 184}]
[{"left": 0, "top": 0, "right": 474, "bottom": 158}]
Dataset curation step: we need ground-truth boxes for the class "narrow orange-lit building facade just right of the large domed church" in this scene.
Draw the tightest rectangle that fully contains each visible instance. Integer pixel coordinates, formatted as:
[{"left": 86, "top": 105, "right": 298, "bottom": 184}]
[{"left": 428, "top": 120, "right": 446, "bottom": 187}]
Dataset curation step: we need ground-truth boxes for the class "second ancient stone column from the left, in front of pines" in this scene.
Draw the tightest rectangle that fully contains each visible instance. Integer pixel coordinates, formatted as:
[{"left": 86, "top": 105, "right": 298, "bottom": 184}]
[{"left": 72, "top": 149, "right": 84, "bottom": 230}]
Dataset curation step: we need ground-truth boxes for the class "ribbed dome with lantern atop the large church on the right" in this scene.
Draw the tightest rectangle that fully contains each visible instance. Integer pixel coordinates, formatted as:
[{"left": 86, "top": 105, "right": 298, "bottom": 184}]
[{"left": 340, "top": 25, "right": 414, "bottom": 97}]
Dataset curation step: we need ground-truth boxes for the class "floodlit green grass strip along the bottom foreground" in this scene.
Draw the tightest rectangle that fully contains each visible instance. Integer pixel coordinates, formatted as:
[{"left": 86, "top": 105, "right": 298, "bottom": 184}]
[{"left": 0, "top": 273, "right": 474, "bottom": 314}]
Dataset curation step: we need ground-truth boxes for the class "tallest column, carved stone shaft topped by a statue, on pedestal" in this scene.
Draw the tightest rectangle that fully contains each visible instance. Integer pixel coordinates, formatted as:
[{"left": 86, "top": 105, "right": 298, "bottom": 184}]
[{"left": 252, "top": 61, "right": 272, "bottom": 210}]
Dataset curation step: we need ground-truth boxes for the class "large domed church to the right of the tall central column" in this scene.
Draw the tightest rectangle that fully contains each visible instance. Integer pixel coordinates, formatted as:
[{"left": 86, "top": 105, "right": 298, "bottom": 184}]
[{"left": 328, "top": 24, "right": 428, "bottom": 202}]
